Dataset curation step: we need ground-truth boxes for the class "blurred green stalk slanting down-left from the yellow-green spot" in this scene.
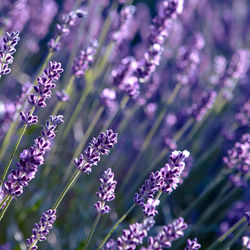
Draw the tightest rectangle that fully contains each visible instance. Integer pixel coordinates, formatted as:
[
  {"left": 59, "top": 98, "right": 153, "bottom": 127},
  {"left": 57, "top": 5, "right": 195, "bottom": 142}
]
[{"left": 63, "top": 84, "right": 92, "bottom": 139}]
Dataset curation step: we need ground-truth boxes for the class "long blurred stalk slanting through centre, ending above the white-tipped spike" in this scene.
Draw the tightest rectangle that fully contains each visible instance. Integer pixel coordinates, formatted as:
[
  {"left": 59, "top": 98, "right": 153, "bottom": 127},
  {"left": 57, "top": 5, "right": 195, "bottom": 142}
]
[{"left": 120, "top": 83, "right": 181, "bottom": 192}]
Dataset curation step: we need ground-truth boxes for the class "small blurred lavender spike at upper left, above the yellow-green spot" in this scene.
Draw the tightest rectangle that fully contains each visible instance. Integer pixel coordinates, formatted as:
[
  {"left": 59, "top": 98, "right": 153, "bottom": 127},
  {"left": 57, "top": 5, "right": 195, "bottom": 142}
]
[{"left": 72, "top": 40, "right": 98, "bottom": 77}]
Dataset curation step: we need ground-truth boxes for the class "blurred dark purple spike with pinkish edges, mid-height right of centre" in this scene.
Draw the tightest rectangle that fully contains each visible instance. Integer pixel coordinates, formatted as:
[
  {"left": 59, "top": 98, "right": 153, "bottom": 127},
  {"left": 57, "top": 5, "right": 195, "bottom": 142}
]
[{"left": 188, "top": 91, "right": 217, "bottom": 121}]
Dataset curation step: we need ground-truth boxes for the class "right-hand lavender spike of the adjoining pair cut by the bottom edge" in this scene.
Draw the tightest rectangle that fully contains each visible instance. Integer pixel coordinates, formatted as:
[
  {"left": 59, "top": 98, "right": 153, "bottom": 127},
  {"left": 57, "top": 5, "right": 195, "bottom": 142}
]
[{"left": 145, "top": 217, "right": 188, "bottom": 250}]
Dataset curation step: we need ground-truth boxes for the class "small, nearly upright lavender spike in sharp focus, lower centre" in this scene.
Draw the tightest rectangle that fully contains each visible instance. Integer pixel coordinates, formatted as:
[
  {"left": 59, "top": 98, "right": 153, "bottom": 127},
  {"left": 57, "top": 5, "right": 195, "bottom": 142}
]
[{"left": 95, "top": 168, "right": 117, "bottom": 214}]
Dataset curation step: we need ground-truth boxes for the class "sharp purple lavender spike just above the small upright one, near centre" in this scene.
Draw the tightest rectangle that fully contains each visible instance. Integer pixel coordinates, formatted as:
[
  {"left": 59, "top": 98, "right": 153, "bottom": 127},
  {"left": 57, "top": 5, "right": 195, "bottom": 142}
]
[{"left": 74, "top": 129, "right": 117, "bottom": 174}]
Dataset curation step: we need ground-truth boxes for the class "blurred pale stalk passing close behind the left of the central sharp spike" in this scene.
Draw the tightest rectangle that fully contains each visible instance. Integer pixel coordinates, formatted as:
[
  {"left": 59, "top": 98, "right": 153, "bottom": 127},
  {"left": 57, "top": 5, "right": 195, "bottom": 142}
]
[{"left": 63, "top": 106, "right": 104, "bottom": 181}]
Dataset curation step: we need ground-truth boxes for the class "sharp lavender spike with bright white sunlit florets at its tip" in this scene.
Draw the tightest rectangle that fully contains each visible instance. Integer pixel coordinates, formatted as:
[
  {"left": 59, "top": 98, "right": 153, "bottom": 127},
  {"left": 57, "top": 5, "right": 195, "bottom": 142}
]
[{"left": 134, "top": 150, "right": 190, "bottom": 216}]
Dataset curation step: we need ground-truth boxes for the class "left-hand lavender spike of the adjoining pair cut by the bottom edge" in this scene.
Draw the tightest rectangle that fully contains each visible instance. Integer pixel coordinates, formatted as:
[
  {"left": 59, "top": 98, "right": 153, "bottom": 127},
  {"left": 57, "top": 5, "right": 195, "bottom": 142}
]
[{"left": 103, "top": 217, "right": 155, "bottom": 250}]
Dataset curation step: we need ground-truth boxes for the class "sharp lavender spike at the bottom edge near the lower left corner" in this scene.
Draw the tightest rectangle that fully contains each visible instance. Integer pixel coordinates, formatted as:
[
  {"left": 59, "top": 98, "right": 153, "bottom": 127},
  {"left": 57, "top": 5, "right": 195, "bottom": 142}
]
[{"left": 26, "top": 209, "right": 56, "bottom": 250}]
